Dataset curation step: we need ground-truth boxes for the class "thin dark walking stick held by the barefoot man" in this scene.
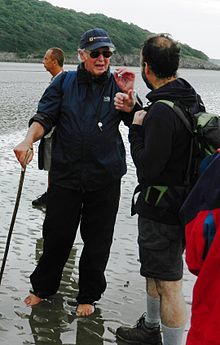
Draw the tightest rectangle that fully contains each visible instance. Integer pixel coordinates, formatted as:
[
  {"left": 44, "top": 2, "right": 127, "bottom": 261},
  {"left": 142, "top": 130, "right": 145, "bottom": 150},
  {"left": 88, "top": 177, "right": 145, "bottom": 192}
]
[{"left": 0, "top": 149, "right": 32, "bottom": 285}]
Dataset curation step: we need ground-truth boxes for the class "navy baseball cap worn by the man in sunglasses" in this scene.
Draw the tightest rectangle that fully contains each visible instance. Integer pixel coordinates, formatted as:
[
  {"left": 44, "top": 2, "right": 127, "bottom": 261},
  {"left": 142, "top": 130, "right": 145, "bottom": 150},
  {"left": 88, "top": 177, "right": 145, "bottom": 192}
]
[{"left": 79, "top": 28, "right": 115, "bottom": 50}]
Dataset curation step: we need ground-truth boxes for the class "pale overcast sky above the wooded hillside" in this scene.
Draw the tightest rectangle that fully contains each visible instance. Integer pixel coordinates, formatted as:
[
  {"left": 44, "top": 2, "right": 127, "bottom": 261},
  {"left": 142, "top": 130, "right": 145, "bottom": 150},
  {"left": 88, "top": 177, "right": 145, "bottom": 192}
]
[{"left": 47, "top": 0, "right": 220, "bottom": 59}]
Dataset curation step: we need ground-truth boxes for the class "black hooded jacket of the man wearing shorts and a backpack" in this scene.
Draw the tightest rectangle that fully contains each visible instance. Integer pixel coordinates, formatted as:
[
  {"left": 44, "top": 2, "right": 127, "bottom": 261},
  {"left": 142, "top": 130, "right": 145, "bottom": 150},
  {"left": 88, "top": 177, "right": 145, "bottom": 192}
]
[{"left": 129, "top": 78, "right": 204, "bottom": 224}]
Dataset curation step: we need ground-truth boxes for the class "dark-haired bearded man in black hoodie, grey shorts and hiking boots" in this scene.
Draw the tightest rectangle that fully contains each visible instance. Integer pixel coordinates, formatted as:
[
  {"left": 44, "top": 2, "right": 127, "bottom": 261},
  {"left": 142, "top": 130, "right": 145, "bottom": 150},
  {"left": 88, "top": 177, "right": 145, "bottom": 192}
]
[{"left": 115, "top": 34, "right": 203, "bottom": 345}]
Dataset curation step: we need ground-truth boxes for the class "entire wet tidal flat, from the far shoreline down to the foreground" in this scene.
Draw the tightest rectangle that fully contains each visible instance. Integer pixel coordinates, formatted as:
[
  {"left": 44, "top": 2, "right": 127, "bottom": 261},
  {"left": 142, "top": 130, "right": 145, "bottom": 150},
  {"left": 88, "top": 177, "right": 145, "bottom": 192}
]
[{"left": 0, "top": 63, "right": 220, "bottom": 345}]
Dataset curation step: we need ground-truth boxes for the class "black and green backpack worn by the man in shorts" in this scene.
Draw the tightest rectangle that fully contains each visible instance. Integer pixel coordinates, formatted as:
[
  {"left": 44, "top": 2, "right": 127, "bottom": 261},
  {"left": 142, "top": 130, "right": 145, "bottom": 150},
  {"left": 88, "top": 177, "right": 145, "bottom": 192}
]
[{"left": 131, "top": 99, "right": 220, "bottom": 215}]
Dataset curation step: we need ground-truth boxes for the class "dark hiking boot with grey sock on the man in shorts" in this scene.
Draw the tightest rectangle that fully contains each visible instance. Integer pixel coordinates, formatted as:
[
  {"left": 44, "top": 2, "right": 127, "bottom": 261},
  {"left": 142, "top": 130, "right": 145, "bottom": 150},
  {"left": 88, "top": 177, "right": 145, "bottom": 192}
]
[{"left": 116, "top": 314, "right": 162, "bottom": 345}]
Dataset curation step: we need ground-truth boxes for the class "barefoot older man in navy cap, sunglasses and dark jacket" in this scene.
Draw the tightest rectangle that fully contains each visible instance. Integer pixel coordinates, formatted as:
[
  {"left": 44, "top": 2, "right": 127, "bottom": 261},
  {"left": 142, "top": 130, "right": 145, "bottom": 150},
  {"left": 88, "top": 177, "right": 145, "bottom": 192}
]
[{"left": 14, "top": 28, "right": 134, "bottom": 316}]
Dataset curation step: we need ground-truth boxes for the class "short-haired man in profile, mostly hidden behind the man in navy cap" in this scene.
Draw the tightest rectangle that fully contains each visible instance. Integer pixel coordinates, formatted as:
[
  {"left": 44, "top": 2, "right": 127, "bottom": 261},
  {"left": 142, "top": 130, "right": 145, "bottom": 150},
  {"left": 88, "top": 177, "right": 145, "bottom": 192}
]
[{"left": 32, "top": 47, "right": 64, "bottom": 207}]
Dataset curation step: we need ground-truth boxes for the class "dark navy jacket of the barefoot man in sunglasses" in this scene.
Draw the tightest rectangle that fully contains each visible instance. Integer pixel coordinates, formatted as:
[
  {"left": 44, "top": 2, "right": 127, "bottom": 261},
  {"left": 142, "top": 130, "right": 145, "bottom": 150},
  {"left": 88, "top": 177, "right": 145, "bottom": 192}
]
[{"left": 30, "top": 65, "right": 133, "bottom": 191}]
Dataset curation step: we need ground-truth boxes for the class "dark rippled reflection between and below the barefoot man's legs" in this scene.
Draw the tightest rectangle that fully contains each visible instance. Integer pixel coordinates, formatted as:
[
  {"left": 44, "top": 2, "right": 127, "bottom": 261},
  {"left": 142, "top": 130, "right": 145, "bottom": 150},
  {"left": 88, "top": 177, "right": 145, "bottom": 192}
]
[{"left": 29, "top": 238, "right": 104, "bottom": 345}]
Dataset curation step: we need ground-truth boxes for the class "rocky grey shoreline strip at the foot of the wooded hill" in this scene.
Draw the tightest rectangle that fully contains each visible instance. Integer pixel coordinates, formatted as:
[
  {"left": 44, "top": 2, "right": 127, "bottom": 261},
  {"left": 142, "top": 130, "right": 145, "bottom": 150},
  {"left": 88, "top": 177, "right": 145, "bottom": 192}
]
[{"left": 0, "top": 52, "right": 220, "bottom": 71}]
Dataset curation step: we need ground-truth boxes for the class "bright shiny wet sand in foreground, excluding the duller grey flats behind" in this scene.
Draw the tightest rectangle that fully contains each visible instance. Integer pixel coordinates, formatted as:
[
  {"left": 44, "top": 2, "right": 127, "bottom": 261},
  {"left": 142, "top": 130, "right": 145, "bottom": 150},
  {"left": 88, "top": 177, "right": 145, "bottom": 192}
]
[{"left": 0, "top": 131, "right": 195, "bottom": 345}]
